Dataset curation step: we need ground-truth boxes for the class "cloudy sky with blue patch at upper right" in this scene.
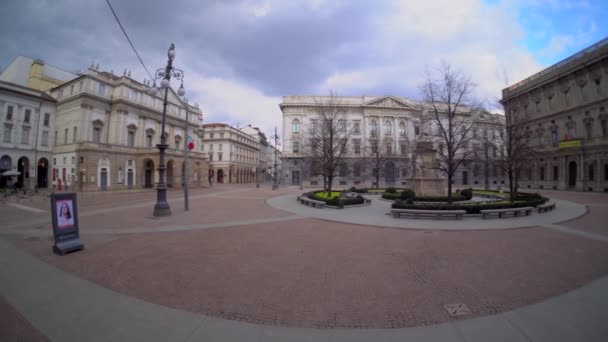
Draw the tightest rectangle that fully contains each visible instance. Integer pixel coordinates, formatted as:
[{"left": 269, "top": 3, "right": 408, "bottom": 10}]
[{"left": 0, "top": 0, "right": 608, "bottom": 136}]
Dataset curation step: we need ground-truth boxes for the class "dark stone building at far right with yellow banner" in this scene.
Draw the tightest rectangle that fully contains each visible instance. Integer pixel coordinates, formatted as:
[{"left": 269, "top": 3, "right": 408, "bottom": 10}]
[{"left": 501, "top": 38, "right": 608, "bottom": 192}]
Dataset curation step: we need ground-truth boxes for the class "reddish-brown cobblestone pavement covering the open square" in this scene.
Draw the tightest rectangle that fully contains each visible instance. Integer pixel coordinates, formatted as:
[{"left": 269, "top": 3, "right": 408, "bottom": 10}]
[{"left": 0, "top": 186, "right": 608, "bottom": 328}]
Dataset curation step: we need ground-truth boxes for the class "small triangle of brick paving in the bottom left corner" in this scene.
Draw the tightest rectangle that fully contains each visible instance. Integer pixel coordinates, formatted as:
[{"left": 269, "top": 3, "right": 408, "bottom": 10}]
[{"left": 0, "top": 295, "right": 48, "bottom": 342}]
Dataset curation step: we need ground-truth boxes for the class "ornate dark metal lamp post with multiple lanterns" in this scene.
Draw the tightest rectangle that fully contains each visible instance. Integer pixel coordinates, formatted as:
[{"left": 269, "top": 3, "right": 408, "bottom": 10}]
[{"left": 150, "top": 43, "right": 186, "bottom": 216}]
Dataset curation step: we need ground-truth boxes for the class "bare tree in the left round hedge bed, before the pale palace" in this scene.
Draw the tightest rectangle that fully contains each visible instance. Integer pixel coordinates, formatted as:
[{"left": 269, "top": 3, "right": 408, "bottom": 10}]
[{"left": 303, "top": 92, "right": 351, "bottom": 195}]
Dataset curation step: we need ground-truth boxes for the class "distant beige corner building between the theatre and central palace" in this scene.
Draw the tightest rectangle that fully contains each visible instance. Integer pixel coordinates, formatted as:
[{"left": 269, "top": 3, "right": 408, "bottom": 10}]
[{"left": 201, "top": 123, "right": 260, "bottom": 183}]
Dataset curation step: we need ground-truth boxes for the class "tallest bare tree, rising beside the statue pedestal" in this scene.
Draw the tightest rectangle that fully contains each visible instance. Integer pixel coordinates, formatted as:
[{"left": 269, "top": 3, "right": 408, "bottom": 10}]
[{"left": 421, "top": 63, "right": 479, "bottom": 203}]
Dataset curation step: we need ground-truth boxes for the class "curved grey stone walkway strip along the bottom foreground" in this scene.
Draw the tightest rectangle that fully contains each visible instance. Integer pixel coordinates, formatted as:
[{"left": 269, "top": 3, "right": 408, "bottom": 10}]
[{"left": 0, "top": 235, "right": 608, "bottom": 342}]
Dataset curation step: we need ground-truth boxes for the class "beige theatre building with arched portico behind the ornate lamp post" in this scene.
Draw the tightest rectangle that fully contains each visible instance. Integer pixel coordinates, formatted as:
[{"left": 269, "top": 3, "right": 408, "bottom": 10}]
[{"left": 50, "top": 67, "right": 208, "bottom": 191}]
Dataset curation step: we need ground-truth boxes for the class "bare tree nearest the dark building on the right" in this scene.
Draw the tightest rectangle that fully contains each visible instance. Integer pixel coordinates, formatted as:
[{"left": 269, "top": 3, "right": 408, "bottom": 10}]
[{"left": 493, "top": 103, "right": 538, "bottom": 202}]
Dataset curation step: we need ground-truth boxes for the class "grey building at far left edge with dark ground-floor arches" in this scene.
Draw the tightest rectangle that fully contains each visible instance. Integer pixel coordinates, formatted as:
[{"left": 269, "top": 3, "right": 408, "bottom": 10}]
[{"left": 0, "top": 81, "right": 56, "bottom": 190}]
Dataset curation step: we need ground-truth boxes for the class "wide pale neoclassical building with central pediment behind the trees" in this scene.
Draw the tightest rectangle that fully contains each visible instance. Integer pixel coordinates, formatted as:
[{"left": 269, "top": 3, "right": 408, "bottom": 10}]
[{"left": 279, "top": 96, "right": 505, "bottom": 187}]
